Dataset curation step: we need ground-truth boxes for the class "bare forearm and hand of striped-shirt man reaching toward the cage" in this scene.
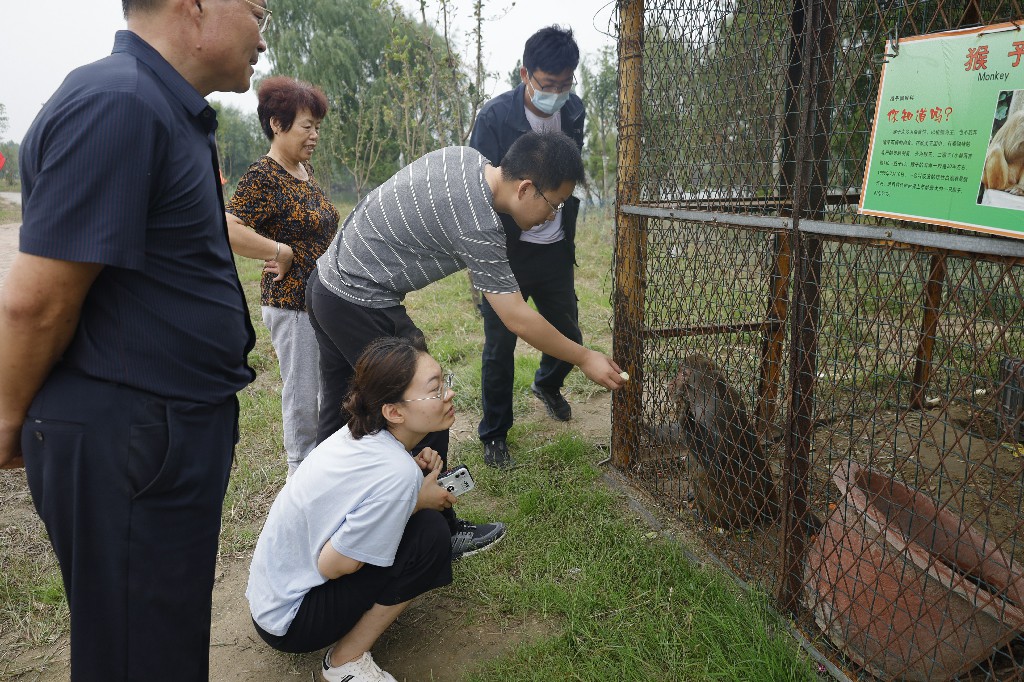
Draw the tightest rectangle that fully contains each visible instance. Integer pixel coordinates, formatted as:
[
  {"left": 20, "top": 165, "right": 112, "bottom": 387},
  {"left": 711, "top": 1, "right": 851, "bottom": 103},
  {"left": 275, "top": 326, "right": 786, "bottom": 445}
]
[{"left": 483, "top": 292, "right": 626, "bottom": 390}]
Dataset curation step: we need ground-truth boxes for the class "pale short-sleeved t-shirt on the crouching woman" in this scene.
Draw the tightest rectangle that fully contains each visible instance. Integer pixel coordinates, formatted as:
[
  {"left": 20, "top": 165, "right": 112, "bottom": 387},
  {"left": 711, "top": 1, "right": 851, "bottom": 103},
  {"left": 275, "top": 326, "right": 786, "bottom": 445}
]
[{"left": 246, "top": 426, "right": 423, "bottom": 635}]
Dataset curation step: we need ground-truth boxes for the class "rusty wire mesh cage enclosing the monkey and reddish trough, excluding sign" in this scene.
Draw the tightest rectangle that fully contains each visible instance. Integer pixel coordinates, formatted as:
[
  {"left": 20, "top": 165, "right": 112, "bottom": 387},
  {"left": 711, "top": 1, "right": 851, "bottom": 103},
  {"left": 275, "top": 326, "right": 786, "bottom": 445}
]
[{"left": 612, "top": 0, "right": 1024, "bottom": 680}]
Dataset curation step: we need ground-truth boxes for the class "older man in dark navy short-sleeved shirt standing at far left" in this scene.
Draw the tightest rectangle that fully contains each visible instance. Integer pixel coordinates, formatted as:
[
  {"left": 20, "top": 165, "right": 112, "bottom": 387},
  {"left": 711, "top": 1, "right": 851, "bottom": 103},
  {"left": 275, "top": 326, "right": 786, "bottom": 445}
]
[{"left": 0, "top": 0, "right": 269, "bottom": 682}]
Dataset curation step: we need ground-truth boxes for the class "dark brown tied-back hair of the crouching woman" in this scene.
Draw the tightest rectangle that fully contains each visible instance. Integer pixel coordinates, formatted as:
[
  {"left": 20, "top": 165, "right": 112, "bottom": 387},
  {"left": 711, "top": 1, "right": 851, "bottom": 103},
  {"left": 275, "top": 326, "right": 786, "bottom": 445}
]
[{"left": 344, "top": 336, "right": 427, "bottom": 439}]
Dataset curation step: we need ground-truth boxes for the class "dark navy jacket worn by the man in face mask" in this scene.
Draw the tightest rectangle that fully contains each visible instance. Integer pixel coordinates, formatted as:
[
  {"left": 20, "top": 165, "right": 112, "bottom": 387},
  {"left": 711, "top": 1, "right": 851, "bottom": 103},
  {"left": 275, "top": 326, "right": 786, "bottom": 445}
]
[{"left": 469, "top": 84, "right": 587, "bottom": 260}]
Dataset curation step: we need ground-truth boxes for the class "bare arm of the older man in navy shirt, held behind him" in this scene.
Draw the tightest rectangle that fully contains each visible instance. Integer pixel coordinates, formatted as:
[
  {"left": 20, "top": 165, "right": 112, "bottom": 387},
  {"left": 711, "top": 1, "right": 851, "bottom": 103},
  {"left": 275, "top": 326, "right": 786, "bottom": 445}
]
[{"left": 0, "top": 253, "right": 102, "bottom": 468}]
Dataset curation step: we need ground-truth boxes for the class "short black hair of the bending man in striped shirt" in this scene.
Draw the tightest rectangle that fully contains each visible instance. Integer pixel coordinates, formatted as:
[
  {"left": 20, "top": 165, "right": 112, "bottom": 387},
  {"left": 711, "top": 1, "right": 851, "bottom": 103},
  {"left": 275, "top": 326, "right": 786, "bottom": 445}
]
[{"left": 501, "top": 130, "right": 587, "bottom": 191}]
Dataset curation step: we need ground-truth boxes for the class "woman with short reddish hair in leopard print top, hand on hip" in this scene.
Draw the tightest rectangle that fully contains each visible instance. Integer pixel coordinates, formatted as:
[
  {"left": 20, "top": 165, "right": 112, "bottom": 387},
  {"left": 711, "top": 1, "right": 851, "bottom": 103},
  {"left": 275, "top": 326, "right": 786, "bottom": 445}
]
[{"left": 227, "top": 77, "right": 340, "bottom": 475}]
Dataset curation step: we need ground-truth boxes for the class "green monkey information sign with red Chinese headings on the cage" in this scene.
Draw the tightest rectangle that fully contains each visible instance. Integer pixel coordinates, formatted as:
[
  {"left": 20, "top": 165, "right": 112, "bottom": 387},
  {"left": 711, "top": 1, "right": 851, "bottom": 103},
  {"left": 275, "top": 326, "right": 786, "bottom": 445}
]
[{"left": 860, "top": 24, "right": 1024, "bottom": 238}]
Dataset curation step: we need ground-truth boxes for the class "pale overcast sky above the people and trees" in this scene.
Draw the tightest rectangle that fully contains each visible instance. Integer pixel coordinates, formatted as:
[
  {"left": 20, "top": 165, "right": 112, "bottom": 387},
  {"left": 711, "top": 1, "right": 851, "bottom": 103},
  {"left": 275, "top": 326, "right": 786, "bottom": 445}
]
[{"left": 0, "top": 0, "right": 616, "bottom": 140}]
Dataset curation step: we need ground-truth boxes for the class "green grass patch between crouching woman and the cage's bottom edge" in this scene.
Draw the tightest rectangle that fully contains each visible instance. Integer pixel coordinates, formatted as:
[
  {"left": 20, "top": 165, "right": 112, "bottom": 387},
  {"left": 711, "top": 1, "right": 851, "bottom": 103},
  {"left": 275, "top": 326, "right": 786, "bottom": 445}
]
[{"left": 451, "top": 434, "right": 815, "bottom": 682}]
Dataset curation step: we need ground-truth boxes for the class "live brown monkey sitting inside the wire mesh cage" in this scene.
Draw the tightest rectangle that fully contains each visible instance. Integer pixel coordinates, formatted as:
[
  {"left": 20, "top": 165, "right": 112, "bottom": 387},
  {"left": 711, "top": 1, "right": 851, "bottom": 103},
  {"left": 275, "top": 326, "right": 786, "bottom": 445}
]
[{"left": 669, "top": 355, "right": 779, "bottom": 530}]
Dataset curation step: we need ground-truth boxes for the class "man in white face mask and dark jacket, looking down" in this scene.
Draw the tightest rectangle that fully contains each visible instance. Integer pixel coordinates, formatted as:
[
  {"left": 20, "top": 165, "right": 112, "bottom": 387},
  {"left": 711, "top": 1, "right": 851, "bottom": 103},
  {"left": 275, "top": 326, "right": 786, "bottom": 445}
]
[{"left": 469, "top": 26, "right": 586, "bottom": 468}]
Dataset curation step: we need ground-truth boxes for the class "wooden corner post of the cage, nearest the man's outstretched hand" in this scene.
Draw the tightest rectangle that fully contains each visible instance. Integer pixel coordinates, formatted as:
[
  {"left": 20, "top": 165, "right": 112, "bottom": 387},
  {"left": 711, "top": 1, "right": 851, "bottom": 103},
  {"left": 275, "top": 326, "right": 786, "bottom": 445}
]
[{"left": 611, "top": 0, "right": 647, "bottom": 468}]
